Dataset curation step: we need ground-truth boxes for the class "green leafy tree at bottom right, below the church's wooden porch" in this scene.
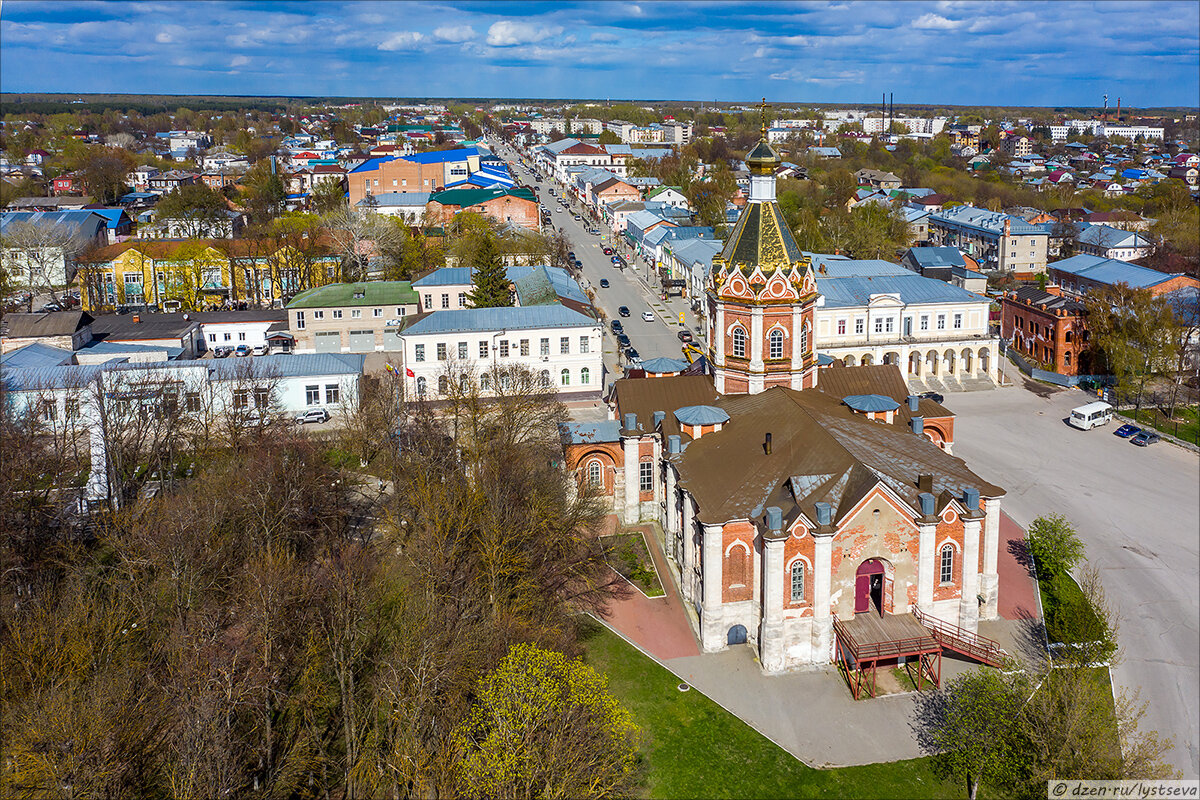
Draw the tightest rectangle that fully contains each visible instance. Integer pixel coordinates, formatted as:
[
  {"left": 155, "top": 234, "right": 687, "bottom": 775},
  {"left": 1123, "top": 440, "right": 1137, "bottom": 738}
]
[{"left": 912, "top": 669, "right": 1030, "bottom": 800}]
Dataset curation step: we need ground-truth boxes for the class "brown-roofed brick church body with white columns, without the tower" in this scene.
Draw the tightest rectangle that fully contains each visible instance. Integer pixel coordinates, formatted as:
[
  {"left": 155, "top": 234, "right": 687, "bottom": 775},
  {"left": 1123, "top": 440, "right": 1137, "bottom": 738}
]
[{"left": 580, "top": 366, "right": 1004, "bottom": 673}]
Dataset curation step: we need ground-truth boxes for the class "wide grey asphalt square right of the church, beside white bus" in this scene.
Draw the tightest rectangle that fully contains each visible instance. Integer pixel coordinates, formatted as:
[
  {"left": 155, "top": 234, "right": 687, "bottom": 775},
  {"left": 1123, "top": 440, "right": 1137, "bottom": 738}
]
[{"left": 946, "top": 371, "right": 1200, "bottom": 778}]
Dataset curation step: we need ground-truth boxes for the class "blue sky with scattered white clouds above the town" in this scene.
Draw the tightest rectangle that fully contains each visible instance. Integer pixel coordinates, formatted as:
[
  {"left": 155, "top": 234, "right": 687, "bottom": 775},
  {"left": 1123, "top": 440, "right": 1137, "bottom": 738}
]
[{"left": 0, "top": 0, "right": 1200, "bottom": 107}]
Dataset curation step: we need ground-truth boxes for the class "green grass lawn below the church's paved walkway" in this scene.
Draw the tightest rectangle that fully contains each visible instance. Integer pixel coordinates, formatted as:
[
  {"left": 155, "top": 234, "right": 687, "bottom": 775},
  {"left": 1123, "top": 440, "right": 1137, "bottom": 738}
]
[{"left": 582, "top": 619, "right": 965, "bottom": 799}]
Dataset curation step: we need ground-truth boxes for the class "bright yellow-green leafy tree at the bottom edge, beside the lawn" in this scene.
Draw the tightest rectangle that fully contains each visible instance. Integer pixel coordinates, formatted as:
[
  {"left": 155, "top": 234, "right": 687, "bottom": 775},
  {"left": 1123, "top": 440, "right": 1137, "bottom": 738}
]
[{"left": 455, "top": 643, "right": 637, "bottom": 798}]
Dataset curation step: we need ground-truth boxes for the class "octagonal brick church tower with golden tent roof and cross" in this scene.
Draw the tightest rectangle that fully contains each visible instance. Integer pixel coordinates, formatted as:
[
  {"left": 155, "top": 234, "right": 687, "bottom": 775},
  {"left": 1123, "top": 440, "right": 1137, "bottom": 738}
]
[{"left": 707, "top": 98, "right": 817, "bottom": 395}]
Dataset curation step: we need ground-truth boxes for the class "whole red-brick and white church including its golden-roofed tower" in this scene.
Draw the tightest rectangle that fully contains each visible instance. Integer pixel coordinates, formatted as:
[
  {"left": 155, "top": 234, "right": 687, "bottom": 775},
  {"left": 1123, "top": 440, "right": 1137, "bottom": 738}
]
[{"left": 563, "top": 122, "right": 1004, "bottom": 681}]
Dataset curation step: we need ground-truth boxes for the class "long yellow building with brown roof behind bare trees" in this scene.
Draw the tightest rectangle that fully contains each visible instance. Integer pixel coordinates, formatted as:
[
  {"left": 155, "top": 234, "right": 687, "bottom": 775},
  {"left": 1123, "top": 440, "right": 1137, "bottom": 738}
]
[{"left": 77, "top": 239, "right": 341, "bottom": 312}]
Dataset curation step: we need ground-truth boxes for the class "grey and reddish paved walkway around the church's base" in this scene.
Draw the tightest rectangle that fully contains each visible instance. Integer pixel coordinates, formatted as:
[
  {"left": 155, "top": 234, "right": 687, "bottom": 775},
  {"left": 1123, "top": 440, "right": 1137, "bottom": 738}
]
[{"left": 602, "top": 516, "right": 1039, "bottom": 768}]
